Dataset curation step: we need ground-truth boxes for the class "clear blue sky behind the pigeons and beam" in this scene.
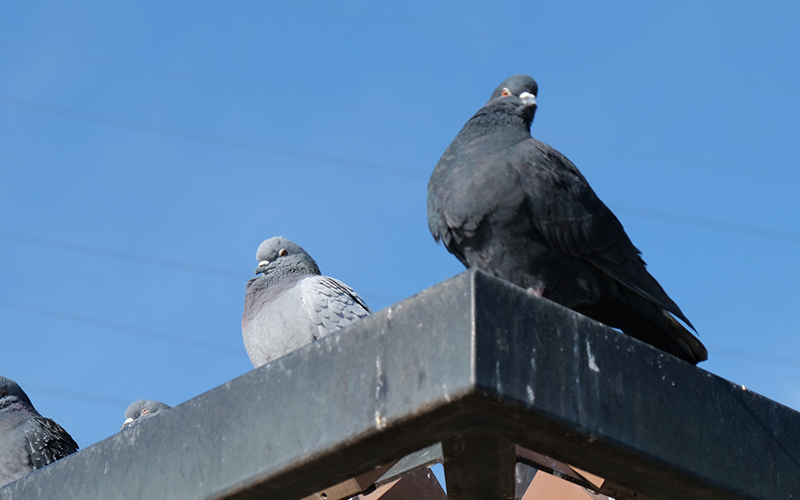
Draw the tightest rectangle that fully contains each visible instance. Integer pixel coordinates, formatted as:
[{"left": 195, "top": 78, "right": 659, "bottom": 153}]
[{"left": 0, "top": 1, "right": 800, "bottom": 460}]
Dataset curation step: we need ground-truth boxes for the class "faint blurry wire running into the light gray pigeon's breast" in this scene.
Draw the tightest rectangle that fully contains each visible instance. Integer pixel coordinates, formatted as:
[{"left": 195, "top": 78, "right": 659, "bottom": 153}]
[{"left": 0, "top": 297, "right": 243, "bottom": 357}]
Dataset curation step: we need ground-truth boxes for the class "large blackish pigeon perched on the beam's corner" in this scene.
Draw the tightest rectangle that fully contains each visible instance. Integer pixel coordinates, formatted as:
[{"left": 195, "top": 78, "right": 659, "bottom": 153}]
[{"left": 428, "top": 75, "right": 708, "bottom": 364}]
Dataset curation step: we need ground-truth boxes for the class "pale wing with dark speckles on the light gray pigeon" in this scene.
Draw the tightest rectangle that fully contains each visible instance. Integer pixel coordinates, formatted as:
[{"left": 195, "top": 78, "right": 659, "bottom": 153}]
[{"left": 301, "top": 276, "right": 372, "bottom": 338}]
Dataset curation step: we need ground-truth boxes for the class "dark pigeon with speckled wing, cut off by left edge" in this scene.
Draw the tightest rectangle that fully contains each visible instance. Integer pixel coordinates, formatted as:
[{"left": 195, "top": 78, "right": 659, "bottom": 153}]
[{"left": 0, "top": 377, "right": 78, "bottom": 486}]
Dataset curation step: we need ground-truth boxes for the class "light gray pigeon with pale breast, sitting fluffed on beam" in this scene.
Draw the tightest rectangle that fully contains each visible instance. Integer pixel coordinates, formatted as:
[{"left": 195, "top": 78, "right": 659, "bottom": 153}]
[{"left": 242, "top": 236, "right": 372, "bottom": 368}]
